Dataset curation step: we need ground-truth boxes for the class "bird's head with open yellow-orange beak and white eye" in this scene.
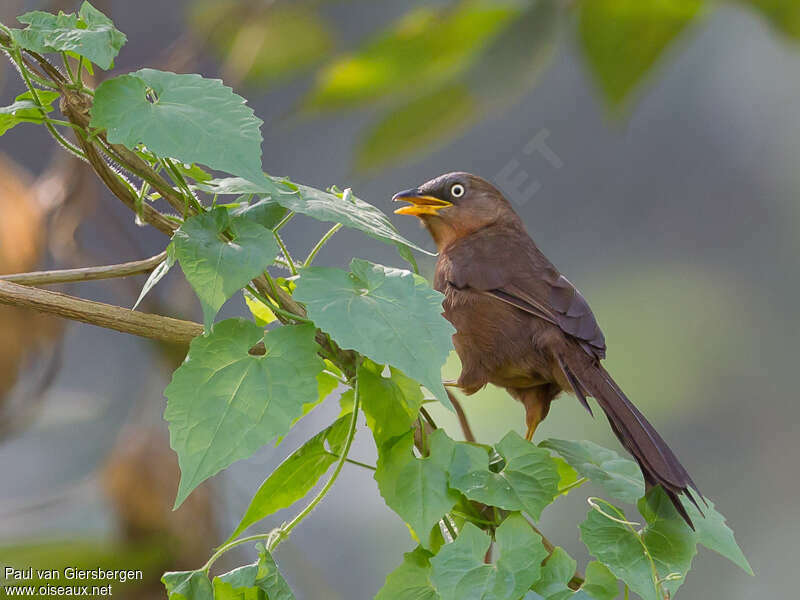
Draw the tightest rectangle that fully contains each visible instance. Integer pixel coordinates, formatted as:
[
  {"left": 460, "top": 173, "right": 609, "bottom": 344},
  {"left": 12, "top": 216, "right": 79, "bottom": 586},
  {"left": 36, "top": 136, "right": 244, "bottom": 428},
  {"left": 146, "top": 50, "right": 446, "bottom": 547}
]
[{"left": 392, "top": 172, "right": 519, "bottom": 250}]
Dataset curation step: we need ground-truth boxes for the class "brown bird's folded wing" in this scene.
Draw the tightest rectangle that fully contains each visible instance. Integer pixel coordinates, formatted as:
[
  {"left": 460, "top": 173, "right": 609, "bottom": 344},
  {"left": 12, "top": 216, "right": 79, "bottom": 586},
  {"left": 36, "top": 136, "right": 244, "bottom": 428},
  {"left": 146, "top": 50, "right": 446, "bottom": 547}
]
[{"left": 445, "top": 233, "right": 606, "bottom": 358}]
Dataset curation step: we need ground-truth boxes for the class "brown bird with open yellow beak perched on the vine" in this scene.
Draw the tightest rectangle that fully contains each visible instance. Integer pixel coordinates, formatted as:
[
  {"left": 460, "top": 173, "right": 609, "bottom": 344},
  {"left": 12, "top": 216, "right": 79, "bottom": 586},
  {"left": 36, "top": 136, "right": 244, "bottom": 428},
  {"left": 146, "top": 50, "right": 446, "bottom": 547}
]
[{"left": 393, "top": 173, "right": 702, "bottom": 526}]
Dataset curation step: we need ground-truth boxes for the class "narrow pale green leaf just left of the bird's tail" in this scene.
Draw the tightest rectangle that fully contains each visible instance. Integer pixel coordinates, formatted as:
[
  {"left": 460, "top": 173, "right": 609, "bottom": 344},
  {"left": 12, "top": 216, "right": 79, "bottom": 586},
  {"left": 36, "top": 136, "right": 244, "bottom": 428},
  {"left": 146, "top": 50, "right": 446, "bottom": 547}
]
[{"left": 539, "top": 438, "right": 644, "bottom": 504}]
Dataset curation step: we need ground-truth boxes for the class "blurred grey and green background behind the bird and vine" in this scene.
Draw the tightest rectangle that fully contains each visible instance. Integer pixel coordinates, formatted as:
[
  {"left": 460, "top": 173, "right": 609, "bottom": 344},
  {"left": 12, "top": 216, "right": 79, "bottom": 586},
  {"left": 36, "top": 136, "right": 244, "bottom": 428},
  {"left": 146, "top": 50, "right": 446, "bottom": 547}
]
[{"left": 0, "top": 0, "right": 800, "bottom": 600}]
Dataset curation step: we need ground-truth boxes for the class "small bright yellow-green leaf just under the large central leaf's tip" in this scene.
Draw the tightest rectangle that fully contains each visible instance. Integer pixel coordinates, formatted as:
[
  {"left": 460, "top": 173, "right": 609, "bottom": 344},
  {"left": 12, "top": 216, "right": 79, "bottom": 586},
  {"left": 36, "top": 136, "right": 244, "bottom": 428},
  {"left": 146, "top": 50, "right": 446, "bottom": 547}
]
[{"left": 358, "top": 361, "right": 424, "bottom": 449}]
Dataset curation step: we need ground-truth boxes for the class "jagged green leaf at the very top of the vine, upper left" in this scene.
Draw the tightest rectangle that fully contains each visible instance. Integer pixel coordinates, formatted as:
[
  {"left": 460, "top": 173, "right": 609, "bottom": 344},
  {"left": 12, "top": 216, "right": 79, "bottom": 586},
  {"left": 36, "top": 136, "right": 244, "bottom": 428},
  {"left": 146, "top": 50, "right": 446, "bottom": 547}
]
[{"left": 11, "top": 2, "right": 128, "bottom": 69}]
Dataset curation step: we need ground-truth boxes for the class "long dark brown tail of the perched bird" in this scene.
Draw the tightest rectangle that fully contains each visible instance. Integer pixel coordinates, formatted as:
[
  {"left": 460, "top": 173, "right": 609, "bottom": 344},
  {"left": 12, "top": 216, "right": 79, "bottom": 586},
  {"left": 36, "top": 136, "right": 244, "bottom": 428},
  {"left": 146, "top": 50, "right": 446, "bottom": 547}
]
[{"left": 560, "top": 356, "right": 703, "bottom": 529}]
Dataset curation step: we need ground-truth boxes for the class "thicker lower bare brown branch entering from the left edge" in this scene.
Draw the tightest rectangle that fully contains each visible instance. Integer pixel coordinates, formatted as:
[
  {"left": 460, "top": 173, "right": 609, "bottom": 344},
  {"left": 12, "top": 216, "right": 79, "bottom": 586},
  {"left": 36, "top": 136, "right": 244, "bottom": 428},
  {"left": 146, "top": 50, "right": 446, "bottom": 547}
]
[{"left": 0, "top": 281, "right": 203, "bottom": 344}]
